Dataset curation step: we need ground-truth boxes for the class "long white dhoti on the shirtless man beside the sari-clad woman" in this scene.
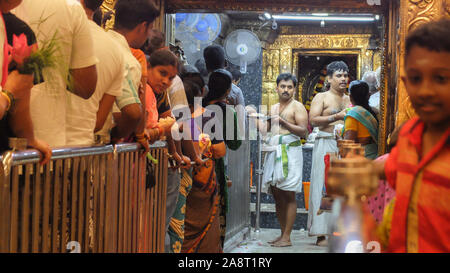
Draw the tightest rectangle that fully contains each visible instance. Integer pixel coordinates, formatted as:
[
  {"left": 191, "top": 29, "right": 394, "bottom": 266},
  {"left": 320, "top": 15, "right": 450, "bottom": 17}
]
[{"left": 307, "top": 131, "right": 339, "bottom": 236}]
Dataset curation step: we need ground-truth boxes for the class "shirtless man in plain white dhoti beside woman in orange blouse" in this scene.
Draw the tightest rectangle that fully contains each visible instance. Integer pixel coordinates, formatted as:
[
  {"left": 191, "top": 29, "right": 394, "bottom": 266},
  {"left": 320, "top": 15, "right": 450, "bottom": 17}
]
[{"left": 308, "top": 61, "right": 350, "bottom": 245}]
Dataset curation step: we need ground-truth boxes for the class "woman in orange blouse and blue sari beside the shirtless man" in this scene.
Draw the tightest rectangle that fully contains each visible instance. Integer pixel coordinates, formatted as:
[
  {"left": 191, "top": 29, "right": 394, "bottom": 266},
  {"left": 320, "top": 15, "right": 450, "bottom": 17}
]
[{"left": 343, "top": 81, "right": 378, "bottom": 159}]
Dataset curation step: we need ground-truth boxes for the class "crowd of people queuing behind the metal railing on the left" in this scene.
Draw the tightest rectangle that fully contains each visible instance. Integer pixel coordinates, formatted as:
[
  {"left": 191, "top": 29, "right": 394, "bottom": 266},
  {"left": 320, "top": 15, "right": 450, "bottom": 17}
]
[{"left": 0, "top": 0, "right": 244, "bottom": 252}]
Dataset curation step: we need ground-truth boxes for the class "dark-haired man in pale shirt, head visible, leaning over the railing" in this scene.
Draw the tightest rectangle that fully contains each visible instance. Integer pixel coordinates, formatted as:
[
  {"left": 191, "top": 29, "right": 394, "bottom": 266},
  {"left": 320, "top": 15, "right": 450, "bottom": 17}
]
[{"left": 108, "top": 0, "right": 159, "bottom": 142}]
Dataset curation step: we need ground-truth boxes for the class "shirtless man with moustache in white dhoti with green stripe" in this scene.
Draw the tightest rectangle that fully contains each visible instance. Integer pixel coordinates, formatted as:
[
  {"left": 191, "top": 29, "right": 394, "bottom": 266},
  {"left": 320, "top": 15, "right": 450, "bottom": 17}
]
[{"left": 251, "top": 73, "right": 308, "bottom": 247}]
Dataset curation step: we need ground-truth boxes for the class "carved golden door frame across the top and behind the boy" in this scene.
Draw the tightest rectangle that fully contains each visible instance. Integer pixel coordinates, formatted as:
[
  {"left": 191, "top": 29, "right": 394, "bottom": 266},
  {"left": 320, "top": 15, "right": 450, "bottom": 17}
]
[{"left": 103, "top": 0, "right": 450, "bottom": 153}]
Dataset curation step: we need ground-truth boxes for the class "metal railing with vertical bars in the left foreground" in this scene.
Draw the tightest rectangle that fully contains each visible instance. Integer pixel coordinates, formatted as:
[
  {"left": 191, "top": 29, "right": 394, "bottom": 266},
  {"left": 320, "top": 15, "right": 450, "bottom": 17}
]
[{"left": 0, "top": 142, "right": 167, "bottom": 253}]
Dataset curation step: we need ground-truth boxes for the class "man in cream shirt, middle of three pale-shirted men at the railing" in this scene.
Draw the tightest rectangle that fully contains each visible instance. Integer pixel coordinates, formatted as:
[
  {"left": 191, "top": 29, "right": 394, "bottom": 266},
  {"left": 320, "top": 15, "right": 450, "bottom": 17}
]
[{"left": 66, "top": 0, "right": 125, "bottom": 145}]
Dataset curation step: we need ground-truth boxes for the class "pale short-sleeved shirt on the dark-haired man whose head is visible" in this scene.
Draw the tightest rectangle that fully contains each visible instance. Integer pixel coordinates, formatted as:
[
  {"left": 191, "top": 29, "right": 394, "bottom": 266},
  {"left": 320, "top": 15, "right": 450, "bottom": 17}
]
[{"left": 108, "top": 30, "right": 142, "bottom": 112}]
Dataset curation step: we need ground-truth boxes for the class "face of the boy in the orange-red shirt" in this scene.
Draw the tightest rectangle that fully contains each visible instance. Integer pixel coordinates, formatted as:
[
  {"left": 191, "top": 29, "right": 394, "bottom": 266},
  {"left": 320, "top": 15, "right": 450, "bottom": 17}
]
[{"left": 402, "top": 46, "right": 450, "bottom": 127}]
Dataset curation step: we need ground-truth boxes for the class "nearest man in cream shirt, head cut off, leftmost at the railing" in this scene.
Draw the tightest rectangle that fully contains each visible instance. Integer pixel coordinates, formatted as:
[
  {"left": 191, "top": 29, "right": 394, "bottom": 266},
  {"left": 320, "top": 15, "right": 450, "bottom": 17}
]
[{"left": 14, "top": 0, "right": 98, "bottom": 147}]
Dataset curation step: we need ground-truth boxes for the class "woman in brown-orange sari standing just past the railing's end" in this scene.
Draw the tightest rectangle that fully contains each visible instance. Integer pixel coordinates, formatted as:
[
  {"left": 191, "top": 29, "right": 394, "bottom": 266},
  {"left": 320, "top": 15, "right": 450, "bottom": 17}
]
[{"left": 181, "top": 71, "right": 226, "bottom": 253}]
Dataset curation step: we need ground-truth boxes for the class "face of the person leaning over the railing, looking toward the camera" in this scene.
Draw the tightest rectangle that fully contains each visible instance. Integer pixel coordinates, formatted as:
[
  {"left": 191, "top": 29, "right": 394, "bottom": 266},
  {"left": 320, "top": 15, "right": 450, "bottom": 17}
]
[{"left": 147, "top": 65, "right": 178, "bottom": 94}]
